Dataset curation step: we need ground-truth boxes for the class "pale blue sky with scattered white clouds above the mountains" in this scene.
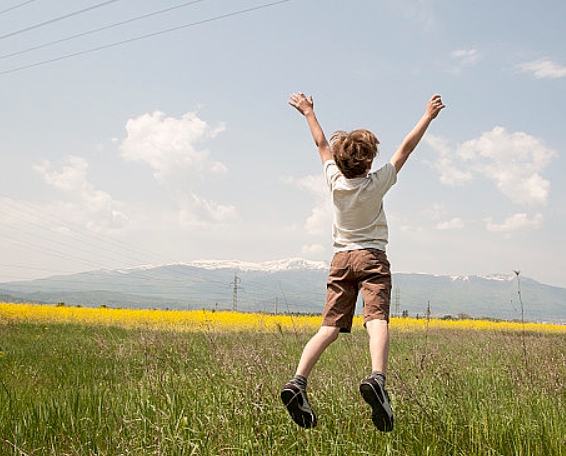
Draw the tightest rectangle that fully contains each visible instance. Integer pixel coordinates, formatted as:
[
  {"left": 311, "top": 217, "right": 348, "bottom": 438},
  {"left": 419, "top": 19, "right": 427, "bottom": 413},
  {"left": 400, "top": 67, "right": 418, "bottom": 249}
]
[{"left": 0, "top": 0, "right": 566, "bottom": 287}]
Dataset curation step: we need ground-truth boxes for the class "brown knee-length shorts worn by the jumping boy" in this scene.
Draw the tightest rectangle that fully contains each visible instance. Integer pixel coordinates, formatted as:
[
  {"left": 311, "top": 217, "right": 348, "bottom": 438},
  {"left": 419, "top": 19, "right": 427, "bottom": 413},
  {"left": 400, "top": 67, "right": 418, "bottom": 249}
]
[{"left": 322, "top": 249, "right": 391, "bottom": 332}]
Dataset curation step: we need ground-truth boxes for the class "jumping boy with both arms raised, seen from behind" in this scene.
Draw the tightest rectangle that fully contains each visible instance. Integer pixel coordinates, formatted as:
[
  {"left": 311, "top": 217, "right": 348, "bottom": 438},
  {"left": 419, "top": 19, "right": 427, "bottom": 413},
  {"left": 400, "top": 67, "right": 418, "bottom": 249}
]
[{"left": 281, "top": 92, "right": 444, "bottom": 432}]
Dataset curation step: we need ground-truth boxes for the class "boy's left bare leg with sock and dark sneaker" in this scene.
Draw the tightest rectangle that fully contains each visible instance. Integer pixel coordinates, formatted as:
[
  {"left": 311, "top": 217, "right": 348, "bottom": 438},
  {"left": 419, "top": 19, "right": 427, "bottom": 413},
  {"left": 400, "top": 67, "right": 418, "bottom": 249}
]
[{"left": 281, "top": 326, "right": 340, "bottom": 428}]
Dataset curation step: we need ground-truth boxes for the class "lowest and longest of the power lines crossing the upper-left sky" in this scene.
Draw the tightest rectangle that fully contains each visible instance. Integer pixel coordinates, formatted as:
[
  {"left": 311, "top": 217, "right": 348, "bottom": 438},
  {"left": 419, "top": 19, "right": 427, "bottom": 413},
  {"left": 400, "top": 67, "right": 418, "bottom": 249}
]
[{"left": 0, "top": 0, "right": 291, "bottom": 75}]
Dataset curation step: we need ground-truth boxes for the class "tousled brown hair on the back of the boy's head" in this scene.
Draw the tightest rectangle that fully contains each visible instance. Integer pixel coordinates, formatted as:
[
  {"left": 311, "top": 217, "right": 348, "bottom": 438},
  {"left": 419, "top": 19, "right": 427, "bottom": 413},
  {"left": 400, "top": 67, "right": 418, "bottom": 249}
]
[{"left": 330, "top": 129, "right": 379, "bottom": 179}]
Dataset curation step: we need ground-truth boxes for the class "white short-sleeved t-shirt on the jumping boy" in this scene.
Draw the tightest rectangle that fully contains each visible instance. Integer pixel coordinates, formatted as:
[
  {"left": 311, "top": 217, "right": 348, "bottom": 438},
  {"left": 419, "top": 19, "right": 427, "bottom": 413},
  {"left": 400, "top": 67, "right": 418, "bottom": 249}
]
[{"left": 324, "top": 160, "right": 397, "bottom": 252}]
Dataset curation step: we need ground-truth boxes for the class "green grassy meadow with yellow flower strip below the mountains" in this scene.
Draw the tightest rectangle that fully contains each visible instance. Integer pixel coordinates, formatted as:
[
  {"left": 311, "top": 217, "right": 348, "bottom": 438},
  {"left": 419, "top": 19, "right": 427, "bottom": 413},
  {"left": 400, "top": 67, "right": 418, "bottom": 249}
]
[{"left": 0, "top": 304, "right": 566, "bottom": 456}]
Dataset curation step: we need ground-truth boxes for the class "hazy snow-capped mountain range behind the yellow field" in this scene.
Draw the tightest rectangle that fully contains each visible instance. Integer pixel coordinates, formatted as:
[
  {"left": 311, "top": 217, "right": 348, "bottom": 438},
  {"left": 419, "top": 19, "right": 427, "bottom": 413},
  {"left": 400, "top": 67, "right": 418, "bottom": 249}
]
[{"left": 0, "top": 258, "right": 566, "bottom": 323}]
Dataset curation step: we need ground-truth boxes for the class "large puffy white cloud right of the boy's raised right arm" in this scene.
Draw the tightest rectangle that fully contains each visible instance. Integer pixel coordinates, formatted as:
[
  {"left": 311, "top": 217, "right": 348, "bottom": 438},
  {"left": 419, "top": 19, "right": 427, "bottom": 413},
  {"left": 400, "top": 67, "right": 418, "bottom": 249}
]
[{"left": 427, "top": 127, "right": 557, "bottom": 206}]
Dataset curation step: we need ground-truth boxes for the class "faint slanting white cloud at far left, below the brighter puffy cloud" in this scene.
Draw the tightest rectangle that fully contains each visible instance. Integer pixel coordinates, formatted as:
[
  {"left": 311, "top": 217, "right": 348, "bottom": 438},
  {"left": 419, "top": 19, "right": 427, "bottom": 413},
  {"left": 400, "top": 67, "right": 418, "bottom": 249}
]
[{"left": 34, "top": 156, "right": 128, "bottom": 234}]
